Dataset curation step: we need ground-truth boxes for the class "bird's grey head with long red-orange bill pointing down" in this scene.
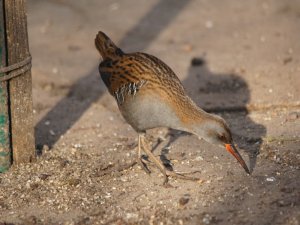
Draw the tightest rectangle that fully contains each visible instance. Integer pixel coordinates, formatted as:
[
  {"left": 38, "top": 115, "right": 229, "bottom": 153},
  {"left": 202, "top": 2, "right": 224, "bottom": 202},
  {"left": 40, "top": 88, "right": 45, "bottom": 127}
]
[{"left": 194, "top": 114, "right": 250, "bottom": 174}]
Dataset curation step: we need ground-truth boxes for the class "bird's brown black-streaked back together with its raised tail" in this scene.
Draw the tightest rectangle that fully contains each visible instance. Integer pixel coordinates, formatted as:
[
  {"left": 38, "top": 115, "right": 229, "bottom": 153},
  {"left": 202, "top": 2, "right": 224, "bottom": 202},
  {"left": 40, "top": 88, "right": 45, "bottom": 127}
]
[{"left": 95, "top": 31, "right": 186, "bottom": 101}]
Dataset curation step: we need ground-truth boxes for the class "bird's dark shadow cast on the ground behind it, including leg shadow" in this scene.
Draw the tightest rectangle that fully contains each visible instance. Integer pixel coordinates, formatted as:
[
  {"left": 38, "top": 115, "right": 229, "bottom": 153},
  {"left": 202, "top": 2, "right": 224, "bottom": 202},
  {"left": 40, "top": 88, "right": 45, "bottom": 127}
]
[{"left": 154, "top": 58, "right": 266, "bottom": 172}]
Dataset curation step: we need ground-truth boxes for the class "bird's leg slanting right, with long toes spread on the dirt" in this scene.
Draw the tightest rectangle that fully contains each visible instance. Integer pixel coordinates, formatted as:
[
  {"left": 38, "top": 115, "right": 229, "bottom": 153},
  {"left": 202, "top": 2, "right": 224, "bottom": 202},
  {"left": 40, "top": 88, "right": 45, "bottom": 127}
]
[{"left": 139, "top": 135, "right": 199, "bottom": 185}]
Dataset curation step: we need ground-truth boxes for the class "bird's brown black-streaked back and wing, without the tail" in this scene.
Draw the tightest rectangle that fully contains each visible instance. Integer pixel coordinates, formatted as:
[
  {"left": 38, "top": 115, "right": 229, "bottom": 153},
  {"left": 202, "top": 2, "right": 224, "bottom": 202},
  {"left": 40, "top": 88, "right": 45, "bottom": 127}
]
[{"left": 99, "top": 53, "right": 185, "bottom": 97}]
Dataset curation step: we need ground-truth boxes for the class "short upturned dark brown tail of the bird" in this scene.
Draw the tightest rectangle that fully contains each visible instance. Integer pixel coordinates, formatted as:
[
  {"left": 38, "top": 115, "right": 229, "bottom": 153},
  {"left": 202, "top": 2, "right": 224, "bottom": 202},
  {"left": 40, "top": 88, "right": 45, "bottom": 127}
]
[{"left": 95, "top": 31, "right": 124, "bottom": 59}]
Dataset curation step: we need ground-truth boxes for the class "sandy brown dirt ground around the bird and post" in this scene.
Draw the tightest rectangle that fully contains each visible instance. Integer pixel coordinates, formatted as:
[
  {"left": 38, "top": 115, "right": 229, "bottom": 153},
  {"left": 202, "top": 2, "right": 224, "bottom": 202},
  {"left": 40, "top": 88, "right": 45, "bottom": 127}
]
[{"left": 0, "top": 0, "right": 300, "bottom": 225}]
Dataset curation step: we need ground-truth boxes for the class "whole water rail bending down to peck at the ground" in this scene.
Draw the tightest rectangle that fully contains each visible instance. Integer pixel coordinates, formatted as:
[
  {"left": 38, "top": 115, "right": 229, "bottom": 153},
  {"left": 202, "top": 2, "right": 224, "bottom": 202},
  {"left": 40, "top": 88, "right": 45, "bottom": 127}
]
[{"left": 95, "top": 31, "right": 250, "bottom": 183}]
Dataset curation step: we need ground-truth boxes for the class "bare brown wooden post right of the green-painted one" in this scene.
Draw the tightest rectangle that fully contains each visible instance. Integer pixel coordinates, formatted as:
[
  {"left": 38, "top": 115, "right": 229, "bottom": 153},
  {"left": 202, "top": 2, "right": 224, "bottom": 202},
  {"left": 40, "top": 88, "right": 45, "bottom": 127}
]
[{"left": 0, "top": 0, "right": 35, "bottom": 167}]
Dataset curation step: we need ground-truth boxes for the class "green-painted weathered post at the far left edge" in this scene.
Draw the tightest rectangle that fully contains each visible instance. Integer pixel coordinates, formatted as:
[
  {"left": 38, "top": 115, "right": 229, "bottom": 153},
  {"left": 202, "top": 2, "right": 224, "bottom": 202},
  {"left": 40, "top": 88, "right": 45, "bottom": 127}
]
[{"left": 0, "top": 0, "right": 12, "bottom": 173}]
